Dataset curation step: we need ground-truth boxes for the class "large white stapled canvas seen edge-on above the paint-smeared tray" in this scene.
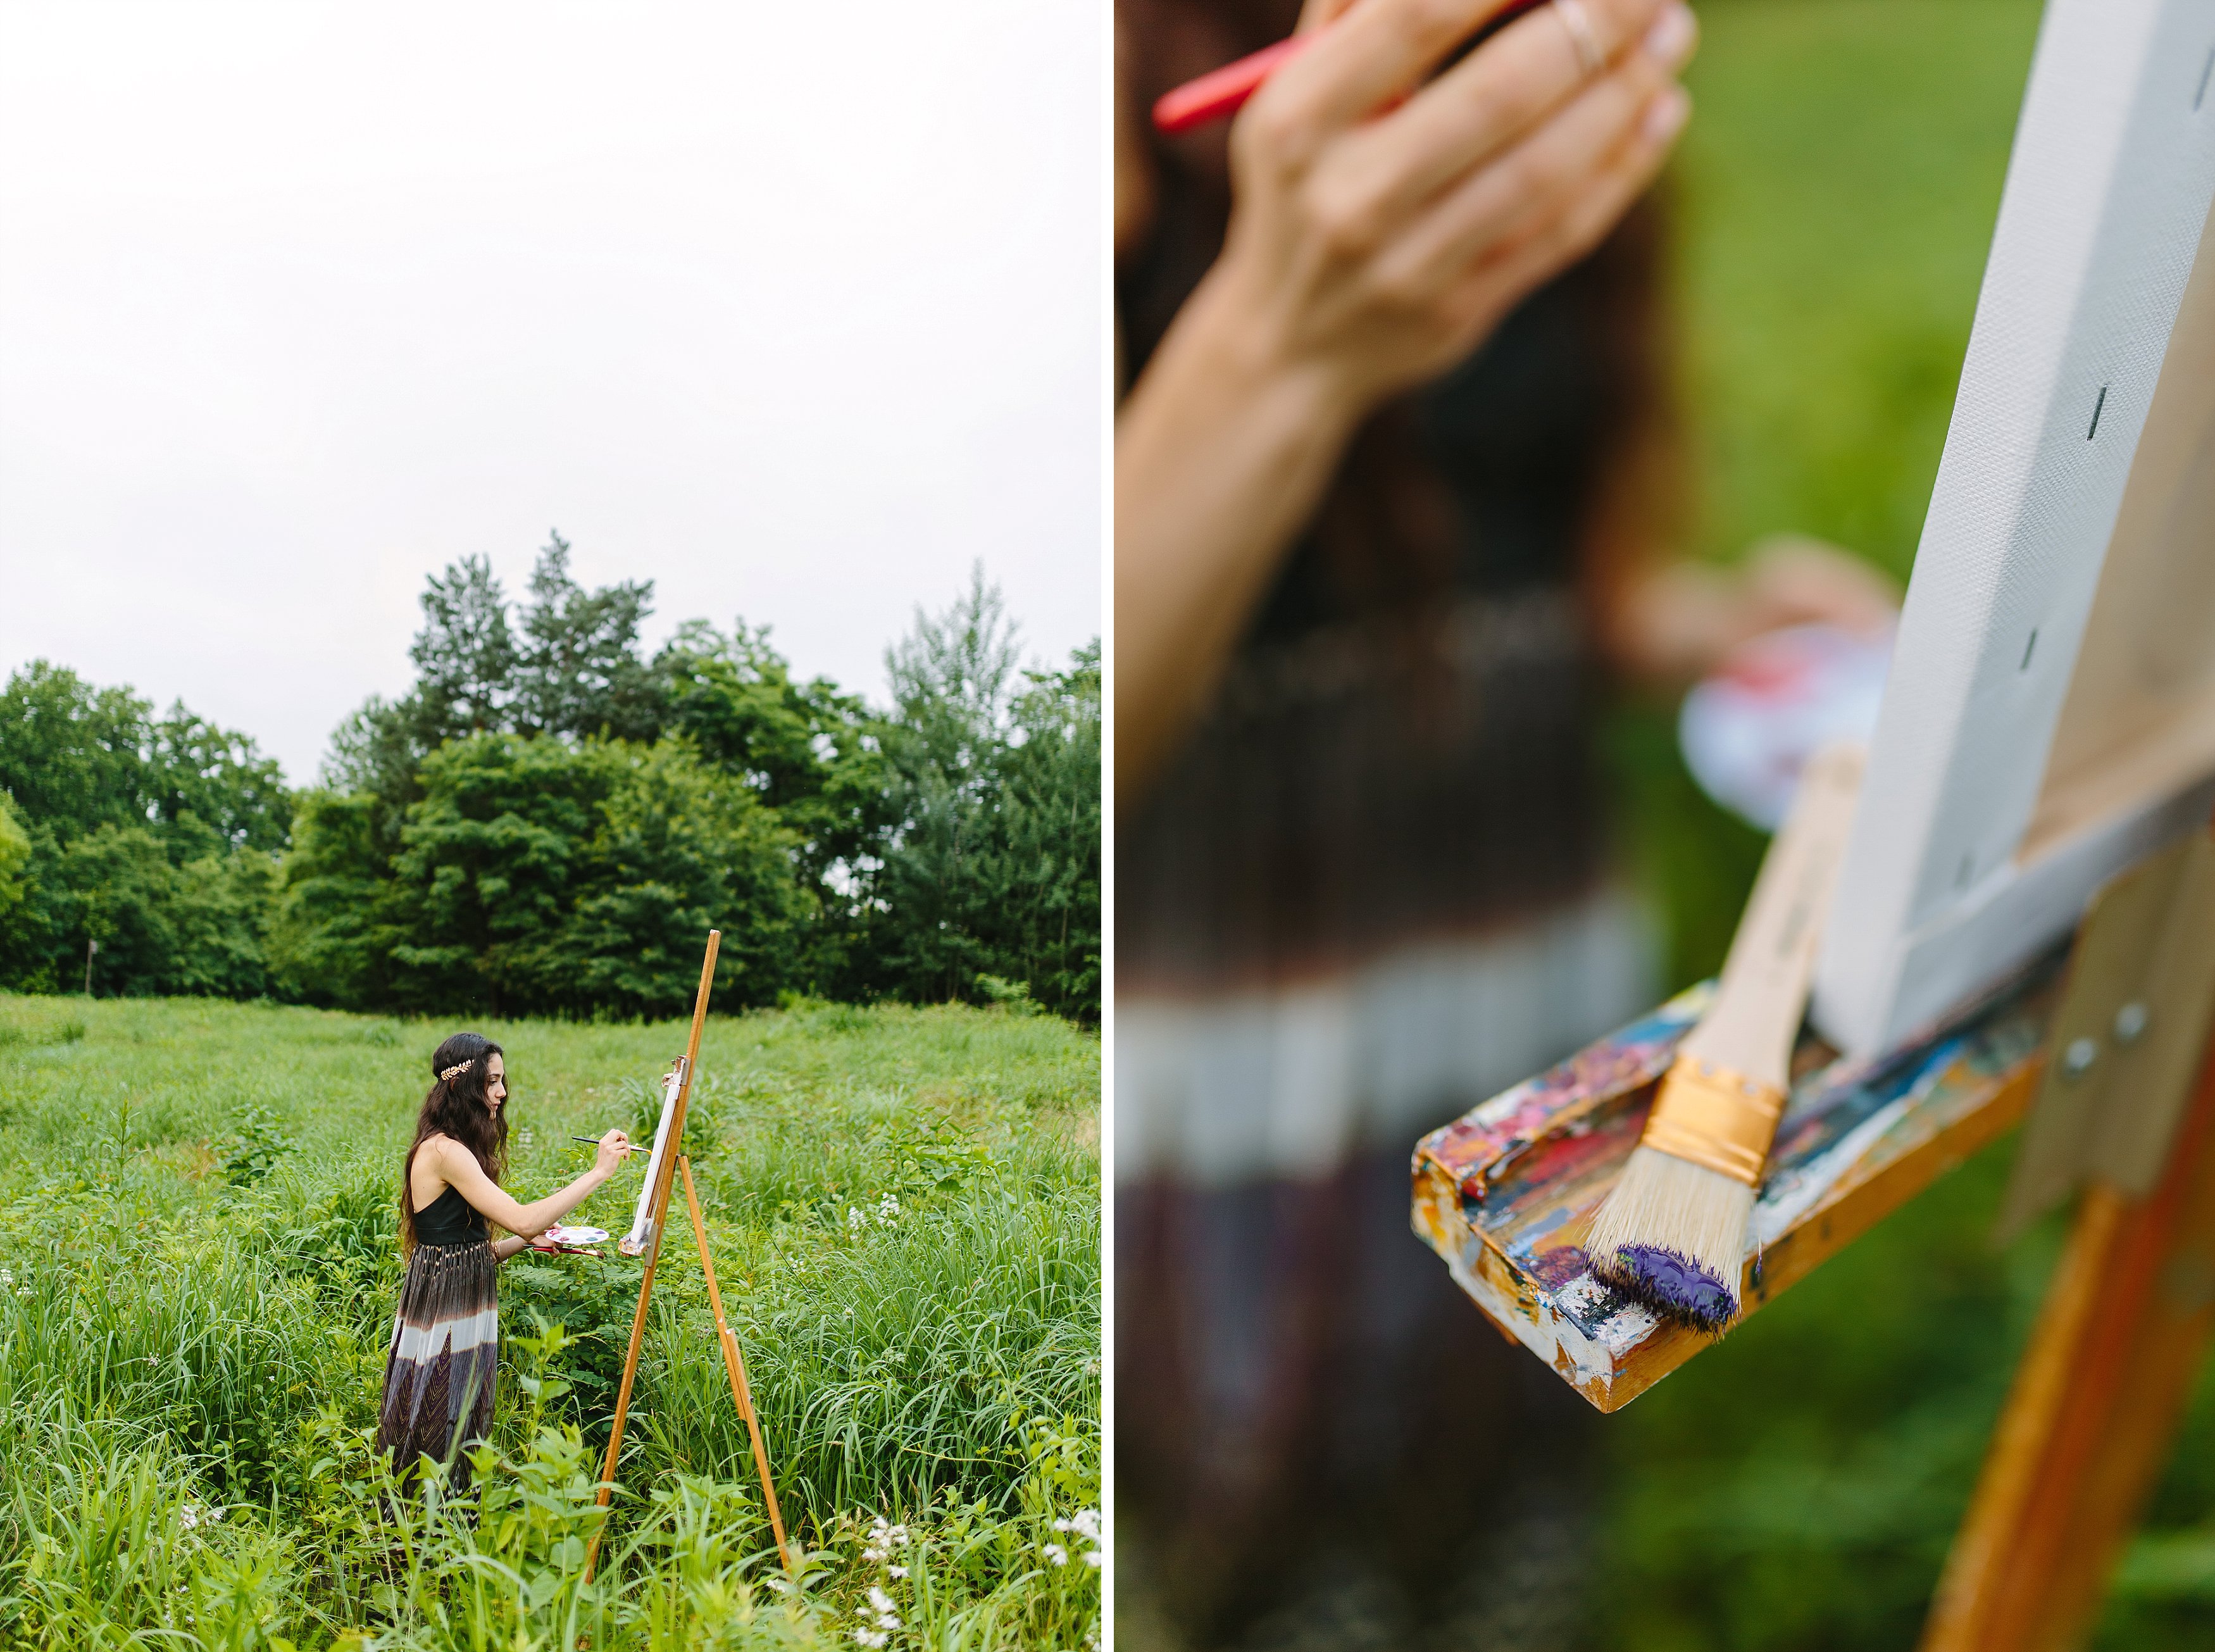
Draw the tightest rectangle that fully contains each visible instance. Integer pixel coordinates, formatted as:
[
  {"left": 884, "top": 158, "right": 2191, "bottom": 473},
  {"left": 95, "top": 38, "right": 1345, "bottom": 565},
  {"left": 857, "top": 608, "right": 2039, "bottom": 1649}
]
[{"left": 1814, "top": 0, "right": 2215, "bottom": 1054}]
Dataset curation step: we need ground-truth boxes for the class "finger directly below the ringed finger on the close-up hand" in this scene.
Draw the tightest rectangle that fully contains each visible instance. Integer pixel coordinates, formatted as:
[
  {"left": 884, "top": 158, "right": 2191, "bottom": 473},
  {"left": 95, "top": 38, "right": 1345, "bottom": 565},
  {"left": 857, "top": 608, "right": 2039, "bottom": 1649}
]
[{"left": 1395, "top": 34, "right": 1675, "bottom": 285}]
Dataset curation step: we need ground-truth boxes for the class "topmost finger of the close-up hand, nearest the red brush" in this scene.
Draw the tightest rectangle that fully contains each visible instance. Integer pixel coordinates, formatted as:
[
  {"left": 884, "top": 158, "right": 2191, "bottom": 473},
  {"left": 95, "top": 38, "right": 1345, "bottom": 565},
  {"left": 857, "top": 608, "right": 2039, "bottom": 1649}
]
[{"left": 1267, "top": 0, "right": 1509, "bottom": 153}]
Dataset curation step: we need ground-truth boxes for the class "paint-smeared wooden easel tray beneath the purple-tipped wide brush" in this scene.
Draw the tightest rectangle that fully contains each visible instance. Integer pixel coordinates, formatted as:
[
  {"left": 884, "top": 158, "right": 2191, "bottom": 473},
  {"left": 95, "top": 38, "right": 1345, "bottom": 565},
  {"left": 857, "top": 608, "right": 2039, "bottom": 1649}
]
[{"left": 1413, "top": 952, "right": 2064, "bottom": 1411}]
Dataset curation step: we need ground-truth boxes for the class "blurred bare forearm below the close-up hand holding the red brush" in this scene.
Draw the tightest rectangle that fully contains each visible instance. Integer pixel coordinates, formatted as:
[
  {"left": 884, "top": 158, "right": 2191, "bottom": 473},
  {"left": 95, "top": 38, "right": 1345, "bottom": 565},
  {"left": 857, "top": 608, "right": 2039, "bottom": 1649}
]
[{"left": 1114, "top": 266, "right": 1354, "bottom": 799}]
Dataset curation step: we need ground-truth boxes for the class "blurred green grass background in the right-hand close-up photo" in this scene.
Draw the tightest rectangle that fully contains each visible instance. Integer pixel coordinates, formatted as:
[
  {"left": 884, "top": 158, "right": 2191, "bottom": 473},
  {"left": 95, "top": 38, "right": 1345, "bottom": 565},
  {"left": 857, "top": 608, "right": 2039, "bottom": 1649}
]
[{"left": 1597, "top": 0, "right": 2215, "bottom": 1652}]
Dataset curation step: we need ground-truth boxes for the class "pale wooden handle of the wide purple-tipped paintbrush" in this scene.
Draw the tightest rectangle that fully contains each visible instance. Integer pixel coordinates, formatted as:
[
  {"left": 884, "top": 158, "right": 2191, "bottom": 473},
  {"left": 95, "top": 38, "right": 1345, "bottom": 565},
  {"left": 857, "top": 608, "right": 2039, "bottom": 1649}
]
[{"left": 1682, "top": 742, "right": 1865, "bottom": 1089}]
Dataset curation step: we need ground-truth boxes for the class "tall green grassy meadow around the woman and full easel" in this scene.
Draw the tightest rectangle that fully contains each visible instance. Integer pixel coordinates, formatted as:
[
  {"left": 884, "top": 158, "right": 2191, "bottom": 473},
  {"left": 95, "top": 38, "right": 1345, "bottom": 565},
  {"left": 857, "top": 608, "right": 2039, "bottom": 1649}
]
[{"left": 0, "top": 996, "right": 1101, "bottom": 1652}]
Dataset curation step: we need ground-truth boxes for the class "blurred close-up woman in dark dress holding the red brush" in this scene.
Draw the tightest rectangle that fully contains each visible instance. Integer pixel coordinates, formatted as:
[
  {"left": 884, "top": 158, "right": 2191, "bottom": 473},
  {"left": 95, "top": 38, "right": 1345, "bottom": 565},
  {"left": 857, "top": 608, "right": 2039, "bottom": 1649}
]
[{"left": 1114, "top": 0, "right": 1892, "bottom": 1648}]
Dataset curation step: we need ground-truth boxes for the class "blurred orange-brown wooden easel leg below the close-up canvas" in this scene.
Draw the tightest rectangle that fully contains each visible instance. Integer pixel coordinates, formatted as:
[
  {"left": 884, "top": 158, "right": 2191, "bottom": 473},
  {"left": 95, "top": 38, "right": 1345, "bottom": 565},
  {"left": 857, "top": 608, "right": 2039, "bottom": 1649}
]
[{"left": 1923, "top": 1023, "right": 2215, "bottom": 1652}]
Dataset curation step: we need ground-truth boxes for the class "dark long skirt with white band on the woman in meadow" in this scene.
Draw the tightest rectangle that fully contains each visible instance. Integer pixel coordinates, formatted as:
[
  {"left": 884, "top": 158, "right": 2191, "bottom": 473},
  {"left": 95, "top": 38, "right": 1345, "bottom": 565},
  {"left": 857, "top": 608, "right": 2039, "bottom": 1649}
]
[{"left": 377, "top": 1240, "right": 501, "bottom": 1491}]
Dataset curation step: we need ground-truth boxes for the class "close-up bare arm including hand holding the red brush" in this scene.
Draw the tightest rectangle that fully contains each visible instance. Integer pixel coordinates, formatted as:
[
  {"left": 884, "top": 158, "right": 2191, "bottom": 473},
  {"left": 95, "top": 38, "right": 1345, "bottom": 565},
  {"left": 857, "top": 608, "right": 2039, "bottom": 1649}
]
[{"left": 1114, "top": 0, "right": 1697, "bottom": 799}]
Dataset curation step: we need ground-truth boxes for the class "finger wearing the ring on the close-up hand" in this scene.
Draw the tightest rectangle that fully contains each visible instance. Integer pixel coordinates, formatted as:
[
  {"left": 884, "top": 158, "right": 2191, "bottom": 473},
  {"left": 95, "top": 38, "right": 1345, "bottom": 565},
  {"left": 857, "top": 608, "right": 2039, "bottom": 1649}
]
[{"left": 1342, "top": 0, "right": 1699, "bottom": 217}]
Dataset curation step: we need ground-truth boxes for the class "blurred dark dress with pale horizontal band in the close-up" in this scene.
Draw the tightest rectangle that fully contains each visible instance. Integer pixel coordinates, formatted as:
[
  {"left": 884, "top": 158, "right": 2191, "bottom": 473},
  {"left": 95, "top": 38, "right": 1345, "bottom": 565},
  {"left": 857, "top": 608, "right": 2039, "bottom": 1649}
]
[{"left": 1114, "top": 0, "right": 1677, "bottom": 1652}]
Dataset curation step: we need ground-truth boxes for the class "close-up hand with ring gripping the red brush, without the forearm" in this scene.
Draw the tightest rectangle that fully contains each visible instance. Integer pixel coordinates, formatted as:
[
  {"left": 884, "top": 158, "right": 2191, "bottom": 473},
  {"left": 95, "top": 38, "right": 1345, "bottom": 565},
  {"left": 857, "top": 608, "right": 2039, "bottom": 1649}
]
[{"left": 1207, "top": 0, "right": 1699, "bottom": 418}]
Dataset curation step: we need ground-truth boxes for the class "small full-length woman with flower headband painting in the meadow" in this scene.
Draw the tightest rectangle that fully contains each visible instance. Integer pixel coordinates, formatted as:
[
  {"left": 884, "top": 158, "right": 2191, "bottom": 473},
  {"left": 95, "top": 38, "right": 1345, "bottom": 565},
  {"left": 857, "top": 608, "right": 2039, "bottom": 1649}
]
[{"left": 377, "top": 1032, "right": 629, "bottom": 1491}]
